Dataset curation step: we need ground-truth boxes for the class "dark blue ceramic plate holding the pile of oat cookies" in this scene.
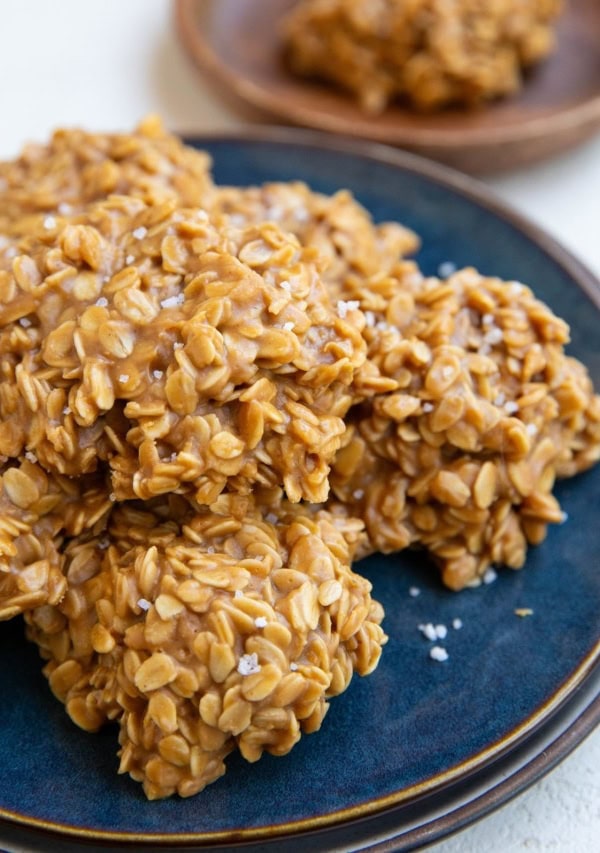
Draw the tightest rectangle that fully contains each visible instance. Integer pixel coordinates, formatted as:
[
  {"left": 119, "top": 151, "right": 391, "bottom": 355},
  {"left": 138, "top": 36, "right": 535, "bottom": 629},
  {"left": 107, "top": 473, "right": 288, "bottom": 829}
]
[{"left": 0, "top": 129, "right": 600, "bottom": 850}]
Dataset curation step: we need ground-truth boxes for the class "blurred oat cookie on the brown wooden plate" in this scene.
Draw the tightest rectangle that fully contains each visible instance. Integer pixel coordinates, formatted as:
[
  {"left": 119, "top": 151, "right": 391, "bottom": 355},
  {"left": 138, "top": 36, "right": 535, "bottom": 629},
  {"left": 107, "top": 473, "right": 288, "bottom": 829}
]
[{"left": 283, "top": 0, "right": 562, "bottom": 113}]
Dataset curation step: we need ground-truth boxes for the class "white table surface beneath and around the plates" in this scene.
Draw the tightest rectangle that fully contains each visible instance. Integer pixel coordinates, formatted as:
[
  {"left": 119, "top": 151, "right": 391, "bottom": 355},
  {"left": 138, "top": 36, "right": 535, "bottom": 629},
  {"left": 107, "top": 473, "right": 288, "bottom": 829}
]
[{"left": 0, "top": 0, "right": 600, "bottom": 853}]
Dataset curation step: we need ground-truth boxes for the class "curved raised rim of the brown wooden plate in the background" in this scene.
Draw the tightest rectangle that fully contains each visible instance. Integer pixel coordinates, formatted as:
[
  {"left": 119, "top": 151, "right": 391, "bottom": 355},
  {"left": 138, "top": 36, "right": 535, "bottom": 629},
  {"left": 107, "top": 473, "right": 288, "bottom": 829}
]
[{"left": 173, "top": 0, "right": 600, "bottom": 154}]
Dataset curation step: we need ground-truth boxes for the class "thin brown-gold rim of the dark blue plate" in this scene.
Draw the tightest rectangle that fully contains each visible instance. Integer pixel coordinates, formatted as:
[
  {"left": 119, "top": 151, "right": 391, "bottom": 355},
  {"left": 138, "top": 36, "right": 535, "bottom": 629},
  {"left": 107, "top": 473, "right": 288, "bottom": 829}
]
[{"left": 0, "top": 125, "right": 600, "bottom": 851}]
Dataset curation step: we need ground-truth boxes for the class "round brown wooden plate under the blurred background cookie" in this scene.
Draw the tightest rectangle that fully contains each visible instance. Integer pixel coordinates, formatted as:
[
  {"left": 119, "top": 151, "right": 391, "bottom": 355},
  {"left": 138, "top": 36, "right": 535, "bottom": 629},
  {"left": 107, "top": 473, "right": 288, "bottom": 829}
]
[{"left": 175, "top": 0, "right": 600, "bottom": 173}]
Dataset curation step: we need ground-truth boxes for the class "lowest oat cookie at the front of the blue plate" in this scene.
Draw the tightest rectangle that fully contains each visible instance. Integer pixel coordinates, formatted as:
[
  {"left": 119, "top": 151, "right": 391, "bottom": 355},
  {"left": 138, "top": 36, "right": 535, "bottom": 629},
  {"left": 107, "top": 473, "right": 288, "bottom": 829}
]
[{"left": 28, "top": 496, "right": 386, "bottom": 799}]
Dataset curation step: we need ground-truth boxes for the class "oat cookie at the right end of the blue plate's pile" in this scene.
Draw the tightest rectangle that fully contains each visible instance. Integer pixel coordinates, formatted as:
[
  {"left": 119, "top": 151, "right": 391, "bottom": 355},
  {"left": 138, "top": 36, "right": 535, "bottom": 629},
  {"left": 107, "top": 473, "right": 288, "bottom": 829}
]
[{"left": 331, "top": 264, "right": 600, "bottom": 589}]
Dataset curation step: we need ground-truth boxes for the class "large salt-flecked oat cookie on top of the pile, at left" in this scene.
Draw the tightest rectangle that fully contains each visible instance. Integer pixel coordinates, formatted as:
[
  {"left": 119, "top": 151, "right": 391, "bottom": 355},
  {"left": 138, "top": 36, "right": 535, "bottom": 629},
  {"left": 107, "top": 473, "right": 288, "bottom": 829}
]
[{"left": 0, "top": 196, "right": 365, "bottom": 504}]
